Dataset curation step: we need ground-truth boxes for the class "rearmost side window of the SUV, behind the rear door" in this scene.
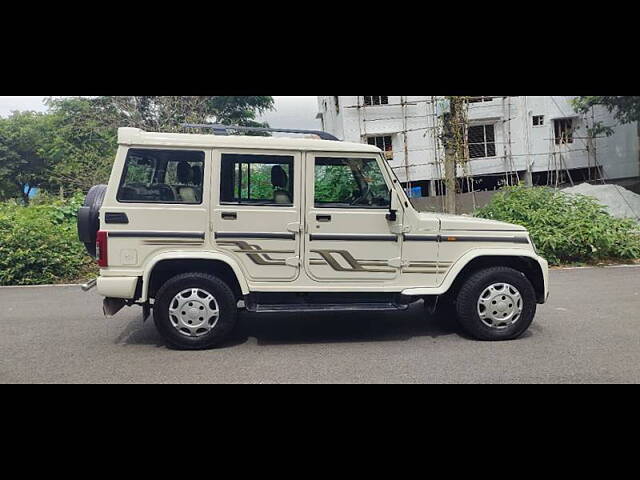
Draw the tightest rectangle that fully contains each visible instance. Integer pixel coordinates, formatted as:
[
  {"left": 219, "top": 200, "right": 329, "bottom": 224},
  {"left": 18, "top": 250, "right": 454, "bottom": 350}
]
[{"left": 117, "top": 149, "right": 204, "bottom": 204}]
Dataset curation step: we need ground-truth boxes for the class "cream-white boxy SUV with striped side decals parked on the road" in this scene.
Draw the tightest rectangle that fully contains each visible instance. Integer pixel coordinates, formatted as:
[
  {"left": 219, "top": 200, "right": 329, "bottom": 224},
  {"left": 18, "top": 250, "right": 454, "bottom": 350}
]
[{"left": 78, "top": 127, "right": 548, "bottom": 349}]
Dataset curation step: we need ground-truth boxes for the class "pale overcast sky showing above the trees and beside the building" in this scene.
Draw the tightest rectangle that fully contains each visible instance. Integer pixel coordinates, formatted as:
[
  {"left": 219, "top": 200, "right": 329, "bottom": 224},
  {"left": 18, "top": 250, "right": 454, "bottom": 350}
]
[{"left": 0, "top": 96, "right": 320, "bottom": 130}]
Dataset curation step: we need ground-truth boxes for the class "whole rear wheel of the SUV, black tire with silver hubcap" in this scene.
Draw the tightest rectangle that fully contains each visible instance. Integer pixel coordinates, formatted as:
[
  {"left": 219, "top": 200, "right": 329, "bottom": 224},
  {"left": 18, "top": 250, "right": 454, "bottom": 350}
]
[{"left": 153, "top": 272, "right": 237, "bottom": 350}]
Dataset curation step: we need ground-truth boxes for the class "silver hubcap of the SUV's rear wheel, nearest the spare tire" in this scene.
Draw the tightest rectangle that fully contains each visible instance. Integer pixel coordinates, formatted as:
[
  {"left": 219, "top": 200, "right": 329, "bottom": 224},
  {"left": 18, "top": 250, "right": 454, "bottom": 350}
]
[{"left": 169, "top": 288, "right": 220, "bottom": 337}]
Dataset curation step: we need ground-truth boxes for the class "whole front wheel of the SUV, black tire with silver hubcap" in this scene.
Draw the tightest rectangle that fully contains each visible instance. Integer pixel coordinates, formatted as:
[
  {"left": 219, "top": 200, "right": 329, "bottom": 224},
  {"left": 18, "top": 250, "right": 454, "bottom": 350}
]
[{"left": 456, "top": 267, "right": 536, "bottom": 340}]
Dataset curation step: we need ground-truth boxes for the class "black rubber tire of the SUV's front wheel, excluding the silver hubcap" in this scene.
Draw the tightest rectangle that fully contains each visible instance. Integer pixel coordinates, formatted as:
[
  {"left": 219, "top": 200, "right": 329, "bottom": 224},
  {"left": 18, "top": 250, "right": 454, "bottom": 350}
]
[{"left": 456, "top": 267, "right": 537, "bottom": 341}]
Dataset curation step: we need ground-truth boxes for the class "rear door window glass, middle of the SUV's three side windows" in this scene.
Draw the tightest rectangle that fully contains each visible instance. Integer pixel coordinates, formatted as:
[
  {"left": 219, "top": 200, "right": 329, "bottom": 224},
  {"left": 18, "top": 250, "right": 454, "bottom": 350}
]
[{"left": 220, "top": 153, "right": 294, "bottom": 205}]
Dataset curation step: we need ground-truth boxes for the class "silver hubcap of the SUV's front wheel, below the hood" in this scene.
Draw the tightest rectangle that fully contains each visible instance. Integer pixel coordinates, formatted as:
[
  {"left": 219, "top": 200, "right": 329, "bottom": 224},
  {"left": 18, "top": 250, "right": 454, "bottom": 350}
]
[{"left": 478, "top": 283, "right": 522, "bottom": 329}]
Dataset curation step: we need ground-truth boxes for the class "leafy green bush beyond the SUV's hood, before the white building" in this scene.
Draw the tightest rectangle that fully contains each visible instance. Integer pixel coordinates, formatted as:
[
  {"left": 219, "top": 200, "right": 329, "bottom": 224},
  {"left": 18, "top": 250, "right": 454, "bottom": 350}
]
[{"left": 475, "top": 186, "right": 640, "bottom": 264}]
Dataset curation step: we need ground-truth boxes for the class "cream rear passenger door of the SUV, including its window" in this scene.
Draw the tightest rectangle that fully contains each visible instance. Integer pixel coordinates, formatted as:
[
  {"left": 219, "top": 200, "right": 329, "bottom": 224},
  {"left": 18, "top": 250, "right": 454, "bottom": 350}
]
[{"left": 212, "top": 150, "right": 302, "bottom": 282}]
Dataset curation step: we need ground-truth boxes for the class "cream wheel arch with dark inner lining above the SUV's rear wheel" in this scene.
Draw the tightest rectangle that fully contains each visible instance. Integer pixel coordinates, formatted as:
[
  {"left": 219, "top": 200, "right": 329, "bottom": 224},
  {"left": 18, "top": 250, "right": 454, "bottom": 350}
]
[{"left": 140, "top": 252, "right": 249, "bottom": 302}]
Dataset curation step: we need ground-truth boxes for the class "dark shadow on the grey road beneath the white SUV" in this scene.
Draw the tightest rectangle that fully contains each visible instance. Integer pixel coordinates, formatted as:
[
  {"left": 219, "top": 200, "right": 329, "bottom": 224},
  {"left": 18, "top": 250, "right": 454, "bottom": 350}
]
[{"left": 116, "top": 304, "right": 461, "bottom": 348}]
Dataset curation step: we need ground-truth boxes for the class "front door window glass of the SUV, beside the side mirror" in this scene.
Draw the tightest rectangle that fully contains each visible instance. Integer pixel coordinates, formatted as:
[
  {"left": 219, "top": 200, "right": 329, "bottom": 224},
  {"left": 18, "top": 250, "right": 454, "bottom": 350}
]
[{"left": 315, "top": 157, "right": 389, "bottom": 208}]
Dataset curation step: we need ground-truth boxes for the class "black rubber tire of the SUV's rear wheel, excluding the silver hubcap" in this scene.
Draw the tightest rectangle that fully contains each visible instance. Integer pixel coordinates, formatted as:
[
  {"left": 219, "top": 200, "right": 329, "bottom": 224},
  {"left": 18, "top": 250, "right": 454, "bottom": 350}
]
[{"left": 153, "top": 272, "right": 238, "bottom": 350}]
